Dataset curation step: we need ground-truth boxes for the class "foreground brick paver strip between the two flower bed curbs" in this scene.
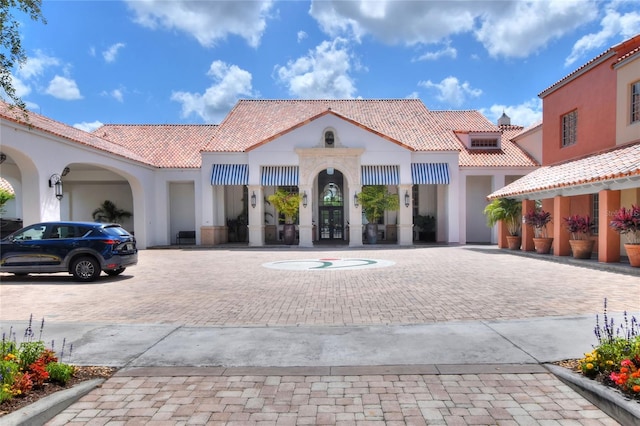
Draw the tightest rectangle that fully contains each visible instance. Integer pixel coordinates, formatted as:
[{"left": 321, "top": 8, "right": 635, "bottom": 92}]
[{"left": 48, "top": 373, "right": 618, "bottom": 426}]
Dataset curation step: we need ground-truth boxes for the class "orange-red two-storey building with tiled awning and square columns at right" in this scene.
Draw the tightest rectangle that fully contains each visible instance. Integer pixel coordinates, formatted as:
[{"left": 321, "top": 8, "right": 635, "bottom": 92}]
[{"left": 489, "top": 35, "right": 640, "bottom": 262}]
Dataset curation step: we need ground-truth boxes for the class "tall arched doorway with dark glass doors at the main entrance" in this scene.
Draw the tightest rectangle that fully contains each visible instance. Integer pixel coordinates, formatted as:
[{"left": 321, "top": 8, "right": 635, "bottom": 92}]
[{"left": 318, "top": 168, "right": 345, "bottom": 241}]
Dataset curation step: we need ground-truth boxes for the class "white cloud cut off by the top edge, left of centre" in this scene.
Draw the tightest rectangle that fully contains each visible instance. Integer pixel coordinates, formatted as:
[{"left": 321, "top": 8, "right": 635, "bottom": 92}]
[{"left": 127, "top": 0, "right": 273, "bottom": 47}]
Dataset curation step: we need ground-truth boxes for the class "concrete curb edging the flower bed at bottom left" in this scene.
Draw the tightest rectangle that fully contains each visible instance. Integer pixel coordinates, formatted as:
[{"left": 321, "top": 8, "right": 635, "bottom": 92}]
[{"left": 0, "top": 379, "right": 105, "bottom": 426}]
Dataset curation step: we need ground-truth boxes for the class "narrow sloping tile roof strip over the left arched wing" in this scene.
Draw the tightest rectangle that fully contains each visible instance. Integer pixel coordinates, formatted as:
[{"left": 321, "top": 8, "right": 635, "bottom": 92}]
[{"left": 0, "top": 101, "right": 151, "bottom": 164}]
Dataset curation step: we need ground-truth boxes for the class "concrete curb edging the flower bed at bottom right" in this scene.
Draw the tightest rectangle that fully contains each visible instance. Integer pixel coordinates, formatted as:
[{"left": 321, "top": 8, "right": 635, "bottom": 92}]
[{"left": 544, "top": 364, "right": 640, "bottom": 425}]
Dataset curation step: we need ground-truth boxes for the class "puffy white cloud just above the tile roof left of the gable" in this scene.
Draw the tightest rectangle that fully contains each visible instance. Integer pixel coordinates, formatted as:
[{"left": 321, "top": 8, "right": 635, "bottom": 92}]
[{"left": 171, "top": 61, "right": 254, "bottom": 123}]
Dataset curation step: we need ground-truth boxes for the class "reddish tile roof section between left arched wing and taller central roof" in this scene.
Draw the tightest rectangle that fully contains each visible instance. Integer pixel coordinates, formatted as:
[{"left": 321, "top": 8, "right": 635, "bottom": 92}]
[{"left": 93, "top": 124, "right": 217, "bottom": 168}]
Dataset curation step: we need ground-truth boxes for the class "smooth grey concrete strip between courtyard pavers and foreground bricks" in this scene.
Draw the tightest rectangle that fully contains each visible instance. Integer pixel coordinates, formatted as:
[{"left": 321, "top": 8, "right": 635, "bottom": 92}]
[{"left": 2, "top": 316, "right": 596, "bottom": 368}]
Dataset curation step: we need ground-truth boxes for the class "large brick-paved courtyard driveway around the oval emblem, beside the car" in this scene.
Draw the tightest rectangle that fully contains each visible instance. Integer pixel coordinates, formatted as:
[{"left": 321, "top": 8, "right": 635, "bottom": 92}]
[{"left": 0, "top": 246, "right": 640, "bottom": 326}]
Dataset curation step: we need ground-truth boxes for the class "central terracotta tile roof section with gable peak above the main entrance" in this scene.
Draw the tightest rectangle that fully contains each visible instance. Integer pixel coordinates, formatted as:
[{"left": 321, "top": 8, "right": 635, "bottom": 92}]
[{"left": 206, "top": 99, "right": 460, "bottom": 152}]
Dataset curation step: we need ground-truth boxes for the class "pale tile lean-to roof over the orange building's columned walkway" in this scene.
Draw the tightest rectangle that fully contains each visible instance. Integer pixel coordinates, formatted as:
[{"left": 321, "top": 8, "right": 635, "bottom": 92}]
[{"left": 488, "top": 142, "right": 640, "bottom": 198}]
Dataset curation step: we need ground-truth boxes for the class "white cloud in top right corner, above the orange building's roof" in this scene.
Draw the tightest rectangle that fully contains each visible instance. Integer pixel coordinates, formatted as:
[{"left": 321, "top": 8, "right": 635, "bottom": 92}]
[{"left": 564, "top": 3, "right": 640, "bottom": 66}]
